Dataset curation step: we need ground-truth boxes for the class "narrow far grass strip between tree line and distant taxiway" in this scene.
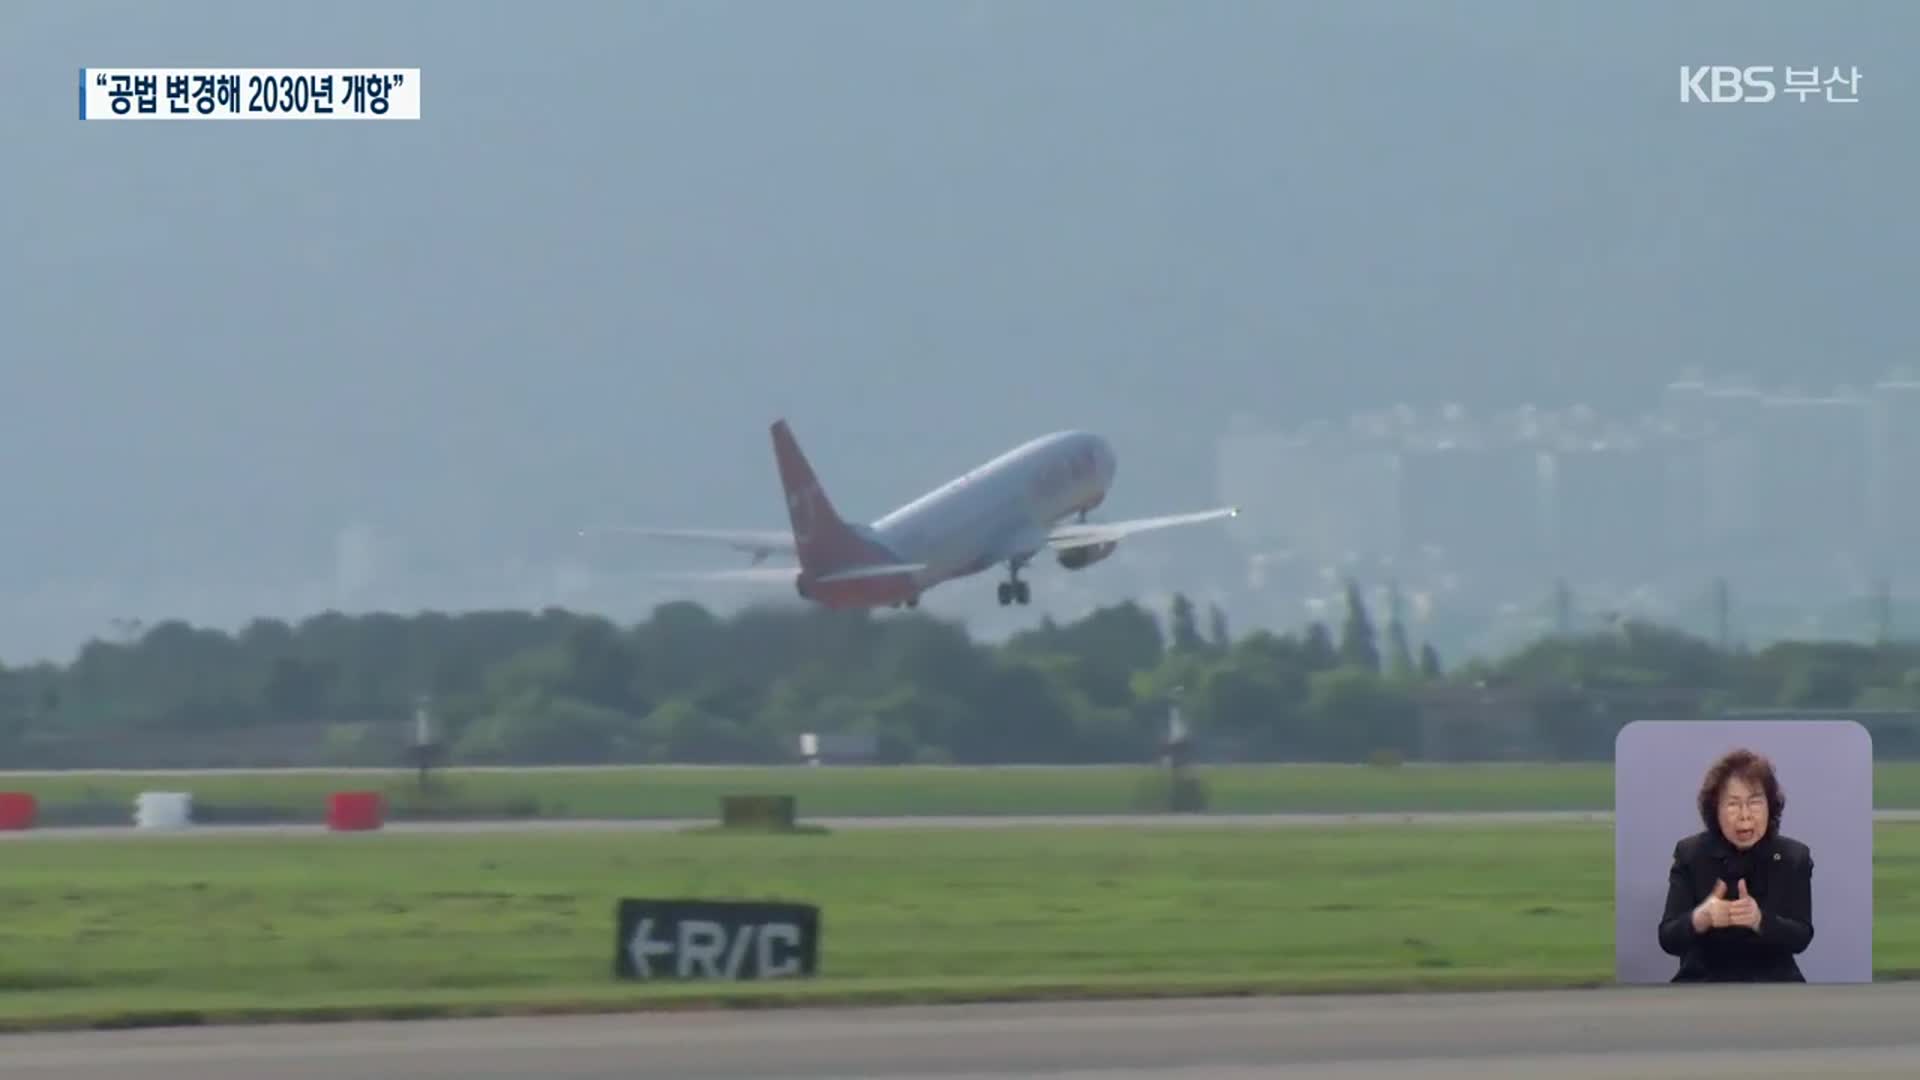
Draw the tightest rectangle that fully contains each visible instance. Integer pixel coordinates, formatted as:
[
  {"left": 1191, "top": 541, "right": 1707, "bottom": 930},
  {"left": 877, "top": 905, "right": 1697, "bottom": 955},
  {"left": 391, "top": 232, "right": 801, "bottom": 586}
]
[{"left": 0, "top": 761, "right": 1920, "bottom": 824}]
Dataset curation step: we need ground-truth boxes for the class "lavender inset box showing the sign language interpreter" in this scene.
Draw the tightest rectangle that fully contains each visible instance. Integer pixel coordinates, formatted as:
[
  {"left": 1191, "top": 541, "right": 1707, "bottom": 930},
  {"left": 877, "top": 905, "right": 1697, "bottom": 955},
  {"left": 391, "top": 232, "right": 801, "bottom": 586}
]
[{"left": 1613, "top": 721, "right": 1874, "bottom": 984}]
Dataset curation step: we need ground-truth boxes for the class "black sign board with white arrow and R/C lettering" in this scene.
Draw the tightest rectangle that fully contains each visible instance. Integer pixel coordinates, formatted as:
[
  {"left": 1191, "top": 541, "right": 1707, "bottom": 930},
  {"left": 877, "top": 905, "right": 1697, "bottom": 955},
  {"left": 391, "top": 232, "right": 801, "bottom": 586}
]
[{"left": 612, "top": 899, "right": 820, "bottom": 980}]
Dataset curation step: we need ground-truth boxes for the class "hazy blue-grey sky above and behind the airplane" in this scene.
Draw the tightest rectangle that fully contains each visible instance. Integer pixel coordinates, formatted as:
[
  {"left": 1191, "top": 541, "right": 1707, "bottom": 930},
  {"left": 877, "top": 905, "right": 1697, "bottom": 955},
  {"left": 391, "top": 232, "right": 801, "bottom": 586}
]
[{"left": 0, "top": 0, "right": 1920, "bottom": 659}]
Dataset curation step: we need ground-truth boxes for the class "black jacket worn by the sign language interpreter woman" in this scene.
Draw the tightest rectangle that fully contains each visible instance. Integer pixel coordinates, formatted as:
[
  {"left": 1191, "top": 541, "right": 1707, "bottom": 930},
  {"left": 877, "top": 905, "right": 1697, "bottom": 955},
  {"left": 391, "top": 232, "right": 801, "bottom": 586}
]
[{"left": 1661, "top": 830, "right": 1812, "bottom": 982}]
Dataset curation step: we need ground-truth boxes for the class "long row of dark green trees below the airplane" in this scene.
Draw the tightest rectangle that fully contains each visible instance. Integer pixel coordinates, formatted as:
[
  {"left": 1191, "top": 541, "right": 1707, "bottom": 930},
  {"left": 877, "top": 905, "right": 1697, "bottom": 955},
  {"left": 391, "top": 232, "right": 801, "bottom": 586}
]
[{"left": 0, "top": 584, "right": 1920, "bottom": 767}]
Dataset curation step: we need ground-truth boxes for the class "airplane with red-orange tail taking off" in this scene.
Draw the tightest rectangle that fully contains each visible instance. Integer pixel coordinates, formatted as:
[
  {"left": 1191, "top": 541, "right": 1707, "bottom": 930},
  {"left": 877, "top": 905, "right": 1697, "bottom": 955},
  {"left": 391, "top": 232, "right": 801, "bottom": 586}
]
[{"left": 582, "top": 419, "right": 1240, "bottom": 609}]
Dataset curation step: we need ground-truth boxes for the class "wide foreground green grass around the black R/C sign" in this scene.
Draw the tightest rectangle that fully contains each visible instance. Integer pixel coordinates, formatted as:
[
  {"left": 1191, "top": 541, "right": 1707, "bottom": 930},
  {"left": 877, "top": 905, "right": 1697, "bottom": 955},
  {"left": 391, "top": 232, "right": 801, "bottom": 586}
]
[{"left": 0, "top": 824, "right": 1920, "bottom": 1030}]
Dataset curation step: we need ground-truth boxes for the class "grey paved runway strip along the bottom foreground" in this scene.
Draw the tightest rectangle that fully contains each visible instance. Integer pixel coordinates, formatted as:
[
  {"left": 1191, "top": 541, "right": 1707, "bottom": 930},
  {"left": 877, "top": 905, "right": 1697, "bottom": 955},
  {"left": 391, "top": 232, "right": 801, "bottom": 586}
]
[{"left": 0, "top": 984, "right": 1920, "bottom": 1080}]
